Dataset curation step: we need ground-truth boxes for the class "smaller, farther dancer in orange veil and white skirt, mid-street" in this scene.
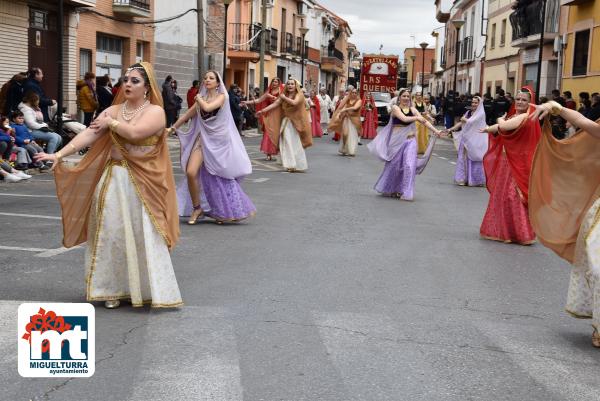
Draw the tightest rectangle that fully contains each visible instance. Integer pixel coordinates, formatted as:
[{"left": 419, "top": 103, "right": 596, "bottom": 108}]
[{"left": 329, "top": 87, "right": 362, "bottom": 156}]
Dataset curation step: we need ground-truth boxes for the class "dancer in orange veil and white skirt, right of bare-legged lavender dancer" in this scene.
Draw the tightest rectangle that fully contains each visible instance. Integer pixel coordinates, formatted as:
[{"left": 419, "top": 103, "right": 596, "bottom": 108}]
[{"left": 257, "top": 79, "right": 312, "bottom": 173}]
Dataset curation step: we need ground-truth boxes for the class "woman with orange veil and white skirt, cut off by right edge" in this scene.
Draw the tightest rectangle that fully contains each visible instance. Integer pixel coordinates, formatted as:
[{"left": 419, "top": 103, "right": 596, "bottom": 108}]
[{"left": 529, "top": 101, "right": 600, "bottom": 347}]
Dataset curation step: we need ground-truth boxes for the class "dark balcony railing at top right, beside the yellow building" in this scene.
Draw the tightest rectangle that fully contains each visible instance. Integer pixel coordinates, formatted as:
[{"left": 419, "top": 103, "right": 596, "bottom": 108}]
[{"left": 509, "top": 0, "right": 560, "bottom": 41}]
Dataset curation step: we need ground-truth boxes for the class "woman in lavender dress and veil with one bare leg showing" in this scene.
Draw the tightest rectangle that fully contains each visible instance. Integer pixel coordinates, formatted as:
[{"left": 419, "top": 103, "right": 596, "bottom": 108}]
[{"left": 173, "top": 70, "right": 256, "bottom": 224}]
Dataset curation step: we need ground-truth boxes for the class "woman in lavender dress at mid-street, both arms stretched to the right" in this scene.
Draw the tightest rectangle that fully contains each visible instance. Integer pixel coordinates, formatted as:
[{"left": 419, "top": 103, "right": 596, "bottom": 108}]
[{"left": 367, "top": 89, "right": 440, "bottom": 200}]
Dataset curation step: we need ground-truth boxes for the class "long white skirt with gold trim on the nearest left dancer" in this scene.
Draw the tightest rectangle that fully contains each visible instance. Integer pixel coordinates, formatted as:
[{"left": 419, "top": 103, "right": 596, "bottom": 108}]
[{"left": 86, "top": 165, "right": 183, "bottom": 307}]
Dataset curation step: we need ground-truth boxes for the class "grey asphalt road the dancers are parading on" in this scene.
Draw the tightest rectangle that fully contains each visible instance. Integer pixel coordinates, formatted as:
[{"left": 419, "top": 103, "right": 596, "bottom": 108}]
[{"left": 0, "top": 130, "right": 600, "bottom": 401}]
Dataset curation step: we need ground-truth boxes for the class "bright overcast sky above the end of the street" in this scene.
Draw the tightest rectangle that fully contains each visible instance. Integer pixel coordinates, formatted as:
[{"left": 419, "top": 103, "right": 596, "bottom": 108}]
[{"left": 318, "top": 0, "right": 441, "bottom": 58}]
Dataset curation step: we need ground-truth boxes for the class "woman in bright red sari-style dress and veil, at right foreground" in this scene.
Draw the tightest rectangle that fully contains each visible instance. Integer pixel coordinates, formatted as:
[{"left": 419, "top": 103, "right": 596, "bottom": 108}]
[{"left": 480, "top": 87, "right": 541, "bottom": 245}]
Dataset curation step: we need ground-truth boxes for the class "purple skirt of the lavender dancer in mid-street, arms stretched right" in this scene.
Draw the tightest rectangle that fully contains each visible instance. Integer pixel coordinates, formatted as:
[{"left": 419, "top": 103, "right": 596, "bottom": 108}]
[{"left": 375, "top": 137, "right": 417, "bottom": 200}]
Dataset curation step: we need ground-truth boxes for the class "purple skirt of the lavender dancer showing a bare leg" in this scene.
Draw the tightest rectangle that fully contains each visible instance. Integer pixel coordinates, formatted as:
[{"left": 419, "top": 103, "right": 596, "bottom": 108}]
[{"left": 200, "top": 164, "right": 256, "bottom": 221}]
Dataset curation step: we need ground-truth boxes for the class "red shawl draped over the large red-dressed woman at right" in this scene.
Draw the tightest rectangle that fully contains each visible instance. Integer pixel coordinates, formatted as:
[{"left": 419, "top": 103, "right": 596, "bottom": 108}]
[{"left": 483, "top": 87, "right": 542, "bottom": 205}]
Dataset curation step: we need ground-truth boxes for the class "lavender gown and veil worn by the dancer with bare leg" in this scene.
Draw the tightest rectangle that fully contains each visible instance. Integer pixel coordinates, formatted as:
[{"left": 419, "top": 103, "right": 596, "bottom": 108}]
[{"left": 177, "top": 78, "right": 256, "bottom": 221}]
